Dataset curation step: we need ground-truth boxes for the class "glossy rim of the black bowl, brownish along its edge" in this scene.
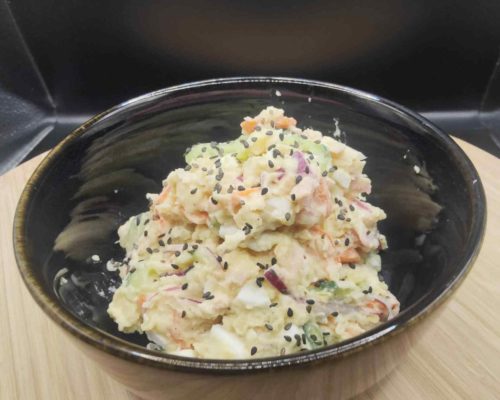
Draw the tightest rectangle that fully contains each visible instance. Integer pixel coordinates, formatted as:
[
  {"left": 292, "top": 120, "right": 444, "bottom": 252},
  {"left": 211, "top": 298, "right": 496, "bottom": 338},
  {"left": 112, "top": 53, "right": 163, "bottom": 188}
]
[{"left": 13, "top": 76, "right": 486, "bottom": 373}]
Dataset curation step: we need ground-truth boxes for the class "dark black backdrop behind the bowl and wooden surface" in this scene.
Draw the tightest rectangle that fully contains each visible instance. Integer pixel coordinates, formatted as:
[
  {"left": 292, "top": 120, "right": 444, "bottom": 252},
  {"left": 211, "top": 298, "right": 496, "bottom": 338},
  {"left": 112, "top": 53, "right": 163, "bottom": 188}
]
[{"left": 0, "top": 0, "right": 500, "bottom": 173}]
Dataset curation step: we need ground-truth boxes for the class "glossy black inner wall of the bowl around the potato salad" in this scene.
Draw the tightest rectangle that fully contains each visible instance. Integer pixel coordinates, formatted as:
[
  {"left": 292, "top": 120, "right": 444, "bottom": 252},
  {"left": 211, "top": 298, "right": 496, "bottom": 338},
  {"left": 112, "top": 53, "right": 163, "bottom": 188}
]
[{"left": 20, "top": 80, "right": 481, "bottom": 356}]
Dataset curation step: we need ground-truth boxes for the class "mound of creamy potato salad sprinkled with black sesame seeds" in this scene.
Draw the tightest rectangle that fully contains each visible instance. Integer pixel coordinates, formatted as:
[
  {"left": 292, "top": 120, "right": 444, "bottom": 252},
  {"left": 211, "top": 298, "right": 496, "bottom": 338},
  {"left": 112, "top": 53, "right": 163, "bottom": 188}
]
[{"left": 108, "top": 107, "right": 399, "bottom": 359}]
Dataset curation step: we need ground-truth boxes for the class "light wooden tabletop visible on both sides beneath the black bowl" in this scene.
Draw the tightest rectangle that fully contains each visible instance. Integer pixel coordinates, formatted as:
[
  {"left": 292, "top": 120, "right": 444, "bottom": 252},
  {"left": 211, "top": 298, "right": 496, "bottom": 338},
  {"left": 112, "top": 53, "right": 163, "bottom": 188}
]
[{"left": 0, "top": 142, "right": 500, "bottom": 400}]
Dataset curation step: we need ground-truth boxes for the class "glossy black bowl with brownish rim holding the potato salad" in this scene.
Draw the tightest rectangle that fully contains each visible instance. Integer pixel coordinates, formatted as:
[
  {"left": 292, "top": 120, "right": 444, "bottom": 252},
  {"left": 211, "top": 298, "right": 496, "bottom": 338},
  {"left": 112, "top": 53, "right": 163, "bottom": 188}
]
[{"left": 14, "top": 78, "right": 486, "bottom": 398}]
